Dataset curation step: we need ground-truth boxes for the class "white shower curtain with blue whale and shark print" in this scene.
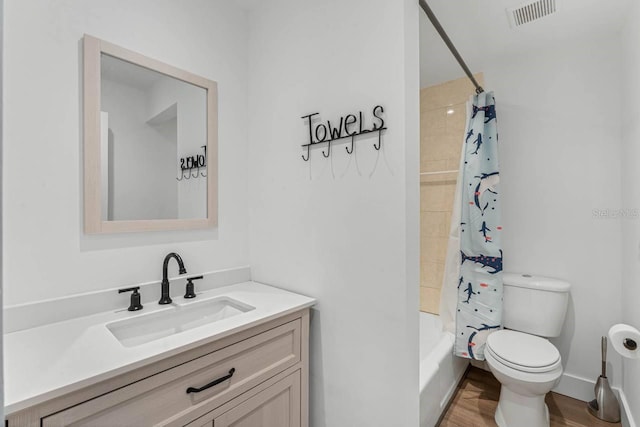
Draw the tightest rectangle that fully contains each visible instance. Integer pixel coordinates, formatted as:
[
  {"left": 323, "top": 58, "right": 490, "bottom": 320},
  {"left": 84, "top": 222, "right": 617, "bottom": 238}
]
[{"left": 440, "top": 92, "right": 502, "bottom": 360}]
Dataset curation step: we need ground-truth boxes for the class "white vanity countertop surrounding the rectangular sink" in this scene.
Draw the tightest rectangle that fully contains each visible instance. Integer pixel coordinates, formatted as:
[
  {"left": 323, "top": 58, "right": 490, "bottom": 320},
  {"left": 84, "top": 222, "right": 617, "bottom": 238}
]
[{"left": 4, "top": 282, "right": 315, "bottom": 415}]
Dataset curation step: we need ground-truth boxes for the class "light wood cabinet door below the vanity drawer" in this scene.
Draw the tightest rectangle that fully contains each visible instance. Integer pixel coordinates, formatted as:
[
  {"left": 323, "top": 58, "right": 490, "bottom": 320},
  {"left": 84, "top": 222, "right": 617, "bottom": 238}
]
[{"left": 213, "top": 371, "right": 301, "bottom": 427}]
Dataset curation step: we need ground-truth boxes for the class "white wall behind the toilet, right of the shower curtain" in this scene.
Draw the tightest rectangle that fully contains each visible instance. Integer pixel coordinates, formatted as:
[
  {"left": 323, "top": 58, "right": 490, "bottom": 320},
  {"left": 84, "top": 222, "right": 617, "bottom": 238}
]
[{"left": 483, "top": 36, "right": 624, "bottom": 400}]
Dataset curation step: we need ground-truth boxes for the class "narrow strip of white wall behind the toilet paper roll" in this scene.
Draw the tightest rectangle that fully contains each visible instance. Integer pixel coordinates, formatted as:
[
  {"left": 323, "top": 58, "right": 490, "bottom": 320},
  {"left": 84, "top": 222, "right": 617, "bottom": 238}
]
[{"left": 621, "top": 2, "right": 640, "bottom": 425}]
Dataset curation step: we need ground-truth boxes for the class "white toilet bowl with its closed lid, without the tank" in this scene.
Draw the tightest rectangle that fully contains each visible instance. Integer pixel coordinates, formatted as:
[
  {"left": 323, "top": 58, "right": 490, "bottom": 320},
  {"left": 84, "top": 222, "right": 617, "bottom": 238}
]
[{"left": 485, "top": 330, "right": 562, "bottom": 427}]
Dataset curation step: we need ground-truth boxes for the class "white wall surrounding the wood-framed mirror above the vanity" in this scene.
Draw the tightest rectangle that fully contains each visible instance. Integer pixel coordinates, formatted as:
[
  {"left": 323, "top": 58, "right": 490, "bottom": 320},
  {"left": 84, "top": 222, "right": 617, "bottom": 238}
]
[{"left": 2, "top": 0, "right": 248, "bottom": 305}]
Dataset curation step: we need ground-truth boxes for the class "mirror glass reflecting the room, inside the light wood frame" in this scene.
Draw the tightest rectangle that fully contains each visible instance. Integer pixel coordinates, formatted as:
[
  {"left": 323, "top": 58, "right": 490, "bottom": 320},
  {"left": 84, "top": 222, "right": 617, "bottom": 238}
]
[{"left": 100, "top": 53, "right": 207, "bottom": 221}]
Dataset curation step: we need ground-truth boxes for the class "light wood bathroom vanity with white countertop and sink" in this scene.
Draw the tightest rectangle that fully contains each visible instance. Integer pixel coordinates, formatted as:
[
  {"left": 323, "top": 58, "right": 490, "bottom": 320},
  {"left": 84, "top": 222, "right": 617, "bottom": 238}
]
[{"left": 5, "top": 282, "right": 314, "bottom": 427}]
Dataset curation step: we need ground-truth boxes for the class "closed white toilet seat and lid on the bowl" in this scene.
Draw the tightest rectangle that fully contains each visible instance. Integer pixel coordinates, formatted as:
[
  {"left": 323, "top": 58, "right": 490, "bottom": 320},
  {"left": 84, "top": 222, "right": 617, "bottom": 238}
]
[{"left": 486, "top": 330, "right": 561, "bottom": 373}]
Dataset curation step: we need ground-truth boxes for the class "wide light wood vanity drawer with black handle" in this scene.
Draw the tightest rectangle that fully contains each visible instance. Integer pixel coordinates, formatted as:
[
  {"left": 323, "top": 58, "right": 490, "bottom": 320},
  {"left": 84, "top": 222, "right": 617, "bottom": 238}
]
[{"left": 42, "top": 319, "right": 301, "bottom": 427}]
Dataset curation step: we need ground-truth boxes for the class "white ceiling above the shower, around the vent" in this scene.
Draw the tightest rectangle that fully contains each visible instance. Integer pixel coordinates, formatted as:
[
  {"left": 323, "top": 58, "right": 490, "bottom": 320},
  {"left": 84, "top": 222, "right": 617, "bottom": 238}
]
[{"left": 420, "top": 0, "right": 638, "bottom": 87}]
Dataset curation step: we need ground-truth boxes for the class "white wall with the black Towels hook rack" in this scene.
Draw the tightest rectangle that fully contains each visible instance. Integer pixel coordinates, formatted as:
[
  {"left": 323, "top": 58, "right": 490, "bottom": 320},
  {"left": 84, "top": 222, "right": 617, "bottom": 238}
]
[{"left": 249, "top": 0, "right": 419, "bottom": 427}]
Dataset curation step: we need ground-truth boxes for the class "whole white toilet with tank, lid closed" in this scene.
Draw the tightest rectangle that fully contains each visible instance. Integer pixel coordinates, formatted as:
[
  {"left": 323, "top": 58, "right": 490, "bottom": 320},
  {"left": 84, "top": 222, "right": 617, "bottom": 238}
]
[{"left": 485, "top": 273, "right": 571, "bottom": 427}]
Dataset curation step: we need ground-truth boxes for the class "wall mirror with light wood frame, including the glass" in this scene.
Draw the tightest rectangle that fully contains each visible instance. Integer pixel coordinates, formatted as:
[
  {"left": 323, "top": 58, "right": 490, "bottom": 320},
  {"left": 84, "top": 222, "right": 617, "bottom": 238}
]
[{"left": 83, "top": 35, "right": 218, "bottom": 234}]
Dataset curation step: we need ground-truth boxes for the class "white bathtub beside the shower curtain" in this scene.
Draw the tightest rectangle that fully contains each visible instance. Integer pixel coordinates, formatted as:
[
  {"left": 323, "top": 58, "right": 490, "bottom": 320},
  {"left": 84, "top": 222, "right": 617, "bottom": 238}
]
[{"left": 420, "top": 312, "right": 469, "bottom": 427}]
